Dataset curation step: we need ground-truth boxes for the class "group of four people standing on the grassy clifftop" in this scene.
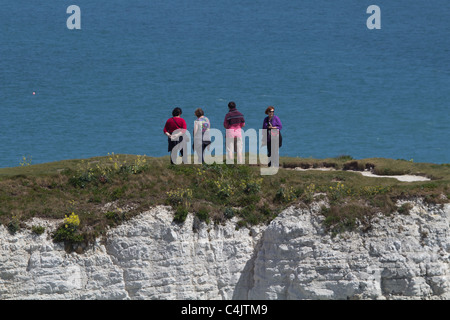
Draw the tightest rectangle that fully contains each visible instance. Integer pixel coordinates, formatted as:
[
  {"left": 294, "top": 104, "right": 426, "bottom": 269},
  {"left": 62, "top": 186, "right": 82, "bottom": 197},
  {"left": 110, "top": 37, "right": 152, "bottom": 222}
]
[{"left": 163, "top": 101, "right": 283, "bottom": 166}]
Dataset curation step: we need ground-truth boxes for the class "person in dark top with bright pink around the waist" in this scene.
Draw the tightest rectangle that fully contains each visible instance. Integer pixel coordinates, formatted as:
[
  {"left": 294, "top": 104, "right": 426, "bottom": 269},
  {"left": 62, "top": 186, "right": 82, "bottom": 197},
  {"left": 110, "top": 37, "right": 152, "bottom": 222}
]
[{"left": 223, "top": 101, "right": 245, "bottom": 164}]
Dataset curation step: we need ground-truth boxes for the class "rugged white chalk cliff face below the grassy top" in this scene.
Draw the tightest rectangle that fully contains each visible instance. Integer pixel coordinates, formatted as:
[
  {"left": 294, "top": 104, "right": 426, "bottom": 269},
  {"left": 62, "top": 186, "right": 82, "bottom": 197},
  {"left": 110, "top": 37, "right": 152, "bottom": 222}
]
[{"left": 0, "top": 201, "right": 450, "bottom": 299}]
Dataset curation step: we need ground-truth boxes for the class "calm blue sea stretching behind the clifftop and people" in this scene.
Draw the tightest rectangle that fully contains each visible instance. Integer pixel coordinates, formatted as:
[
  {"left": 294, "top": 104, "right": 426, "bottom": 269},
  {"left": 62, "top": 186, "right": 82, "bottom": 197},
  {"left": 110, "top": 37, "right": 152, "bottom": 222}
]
[{"left": 0, "top": 0, "right": 450, "bottom": 167}]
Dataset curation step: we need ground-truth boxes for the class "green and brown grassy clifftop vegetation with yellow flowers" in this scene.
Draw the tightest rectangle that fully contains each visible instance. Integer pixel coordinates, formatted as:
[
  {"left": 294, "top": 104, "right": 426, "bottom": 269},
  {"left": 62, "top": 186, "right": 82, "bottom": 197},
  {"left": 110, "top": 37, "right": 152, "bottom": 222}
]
[{"left": 0, "top": 155, "right": 450, "bottom": 248}]
